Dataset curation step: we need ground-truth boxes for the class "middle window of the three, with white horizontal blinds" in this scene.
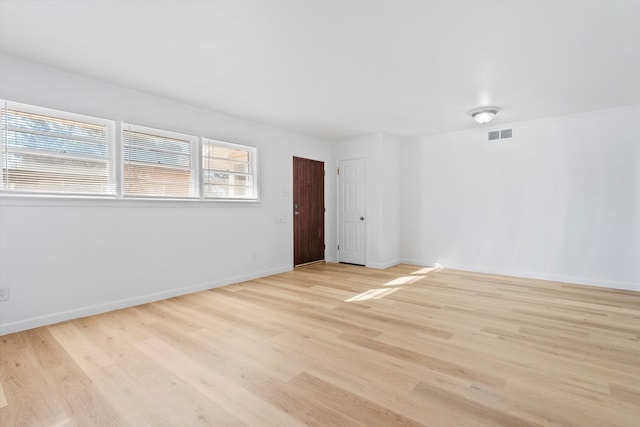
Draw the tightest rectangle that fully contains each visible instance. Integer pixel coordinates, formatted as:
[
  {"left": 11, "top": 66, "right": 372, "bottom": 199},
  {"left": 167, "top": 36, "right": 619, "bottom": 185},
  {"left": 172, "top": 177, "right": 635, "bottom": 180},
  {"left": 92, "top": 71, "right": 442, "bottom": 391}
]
[{"left": 122, "top": 124, "right": 198, "bottom": 198}]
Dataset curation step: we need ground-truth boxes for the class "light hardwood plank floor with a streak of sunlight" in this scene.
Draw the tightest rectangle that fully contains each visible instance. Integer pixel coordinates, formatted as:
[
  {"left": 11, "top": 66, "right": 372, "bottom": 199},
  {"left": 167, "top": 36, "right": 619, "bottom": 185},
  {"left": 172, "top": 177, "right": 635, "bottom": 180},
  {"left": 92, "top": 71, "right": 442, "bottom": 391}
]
[{"left": 0, "top": 264, "right": 640, "bottom": 427}]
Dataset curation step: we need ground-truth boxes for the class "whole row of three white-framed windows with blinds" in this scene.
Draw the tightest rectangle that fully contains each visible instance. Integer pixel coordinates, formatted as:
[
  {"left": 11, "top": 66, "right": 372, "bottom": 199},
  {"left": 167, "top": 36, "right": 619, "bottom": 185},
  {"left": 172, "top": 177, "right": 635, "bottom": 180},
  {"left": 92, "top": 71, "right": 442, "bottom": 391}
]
[{"left": 0, "top": 100, "right": 258, "bottom": 200}]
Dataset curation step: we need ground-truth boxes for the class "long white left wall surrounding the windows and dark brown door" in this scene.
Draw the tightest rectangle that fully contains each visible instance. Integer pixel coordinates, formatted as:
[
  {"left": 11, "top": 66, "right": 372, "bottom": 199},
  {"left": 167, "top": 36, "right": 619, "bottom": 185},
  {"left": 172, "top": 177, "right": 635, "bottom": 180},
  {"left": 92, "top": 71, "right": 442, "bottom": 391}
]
[{"left": 0, "top": 56, "right": 336, "bottom": 335}]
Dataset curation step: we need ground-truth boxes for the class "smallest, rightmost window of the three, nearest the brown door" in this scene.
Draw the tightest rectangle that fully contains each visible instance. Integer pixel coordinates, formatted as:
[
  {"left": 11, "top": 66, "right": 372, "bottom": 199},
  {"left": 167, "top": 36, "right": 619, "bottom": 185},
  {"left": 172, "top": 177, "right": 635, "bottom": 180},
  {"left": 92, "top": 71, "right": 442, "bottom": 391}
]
[{"left": 202, "top": 139, "right": 257, "bottom": 200}]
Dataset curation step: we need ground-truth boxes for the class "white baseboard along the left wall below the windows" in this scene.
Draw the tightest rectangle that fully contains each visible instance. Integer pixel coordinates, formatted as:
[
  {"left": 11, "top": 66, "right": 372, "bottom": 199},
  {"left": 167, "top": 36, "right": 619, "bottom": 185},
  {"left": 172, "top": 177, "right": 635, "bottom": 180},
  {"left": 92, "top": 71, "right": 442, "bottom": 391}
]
[{"left": 0, "top": 266, "right": 293, "bottom": 336}]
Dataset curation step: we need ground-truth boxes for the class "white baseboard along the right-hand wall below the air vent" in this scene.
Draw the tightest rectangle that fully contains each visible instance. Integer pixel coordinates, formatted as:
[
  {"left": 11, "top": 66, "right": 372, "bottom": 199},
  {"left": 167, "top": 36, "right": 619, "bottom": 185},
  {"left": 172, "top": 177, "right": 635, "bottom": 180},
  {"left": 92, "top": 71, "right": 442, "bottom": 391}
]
[{"left": 402, "top": 258, "right": 640, "bottom": 291}]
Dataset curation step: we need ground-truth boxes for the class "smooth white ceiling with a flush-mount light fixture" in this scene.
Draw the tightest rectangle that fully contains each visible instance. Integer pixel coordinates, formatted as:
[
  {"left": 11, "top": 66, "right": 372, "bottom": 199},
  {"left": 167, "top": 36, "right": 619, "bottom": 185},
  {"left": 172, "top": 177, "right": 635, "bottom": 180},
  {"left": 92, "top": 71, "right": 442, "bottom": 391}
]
[{"left": 0, "top": 0, "right": 640, "bottom": 138}]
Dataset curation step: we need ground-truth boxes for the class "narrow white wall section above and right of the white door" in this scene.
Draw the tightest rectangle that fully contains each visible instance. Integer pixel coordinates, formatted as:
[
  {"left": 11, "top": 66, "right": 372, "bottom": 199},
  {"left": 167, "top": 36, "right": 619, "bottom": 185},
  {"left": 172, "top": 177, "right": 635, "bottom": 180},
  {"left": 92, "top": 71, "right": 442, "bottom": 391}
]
[{"left": 333, "top": 134, "right": 401, "bottom": 268}]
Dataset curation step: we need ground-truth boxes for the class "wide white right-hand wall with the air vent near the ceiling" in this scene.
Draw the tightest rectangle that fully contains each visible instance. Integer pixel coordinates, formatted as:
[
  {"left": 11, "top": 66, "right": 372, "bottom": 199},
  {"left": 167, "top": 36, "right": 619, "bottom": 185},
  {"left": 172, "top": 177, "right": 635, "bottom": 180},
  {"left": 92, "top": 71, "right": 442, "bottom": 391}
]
[{"left": 401, "top": 107, "right": 640, "bottom": 290}]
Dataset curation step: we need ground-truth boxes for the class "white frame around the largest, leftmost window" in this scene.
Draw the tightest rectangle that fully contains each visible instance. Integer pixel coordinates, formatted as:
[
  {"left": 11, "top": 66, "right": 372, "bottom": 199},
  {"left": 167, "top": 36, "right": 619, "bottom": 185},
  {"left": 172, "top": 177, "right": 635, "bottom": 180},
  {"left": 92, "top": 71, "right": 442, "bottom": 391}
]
[{"left": 0, "top": 99, "right": 119, "bottom": 198}]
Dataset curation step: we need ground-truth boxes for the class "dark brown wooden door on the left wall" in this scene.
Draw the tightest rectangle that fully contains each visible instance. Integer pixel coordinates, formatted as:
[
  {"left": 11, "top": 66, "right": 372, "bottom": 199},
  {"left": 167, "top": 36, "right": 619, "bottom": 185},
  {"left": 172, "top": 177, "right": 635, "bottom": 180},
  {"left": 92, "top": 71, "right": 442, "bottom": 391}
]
[{"left": 293, "top": 157, "right": 324, "bottom": 266}]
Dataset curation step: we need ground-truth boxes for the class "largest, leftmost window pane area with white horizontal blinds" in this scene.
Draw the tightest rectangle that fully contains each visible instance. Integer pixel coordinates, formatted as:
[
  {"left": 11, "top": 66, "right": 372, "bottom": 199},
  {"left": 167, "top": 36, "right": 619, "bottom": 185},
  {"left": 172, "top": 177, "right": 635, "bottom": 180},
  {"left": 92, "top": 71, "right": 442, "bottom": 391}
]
[{"left": 0, "top": 101, "right": 116, "bottom": 195}]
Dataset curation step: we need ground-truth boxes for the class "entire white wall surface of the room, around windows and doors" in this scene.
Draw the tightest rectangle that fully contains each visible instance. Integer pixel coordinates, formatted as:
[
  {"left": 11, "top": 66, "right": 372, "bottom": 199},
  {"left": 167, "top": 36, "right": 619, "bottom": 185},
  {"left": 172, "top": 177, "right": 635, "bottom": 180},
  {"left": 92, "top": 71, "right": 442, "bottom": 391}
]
[{"left": 0, "top": 56, "right": 640, "bottom": 334}]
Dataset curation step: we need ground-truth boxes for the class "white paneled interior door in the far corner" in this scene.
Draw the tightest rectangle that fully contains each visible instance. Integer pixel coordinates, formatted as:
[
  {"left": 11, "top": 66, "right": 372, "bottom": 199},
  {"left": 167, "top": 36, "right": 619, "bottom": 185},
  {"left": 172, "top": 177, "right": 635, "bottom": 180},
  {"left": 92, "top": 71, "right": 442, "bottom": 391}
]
[{"left": 338, "top": 159, "right": 366, "bottom": 265}]
